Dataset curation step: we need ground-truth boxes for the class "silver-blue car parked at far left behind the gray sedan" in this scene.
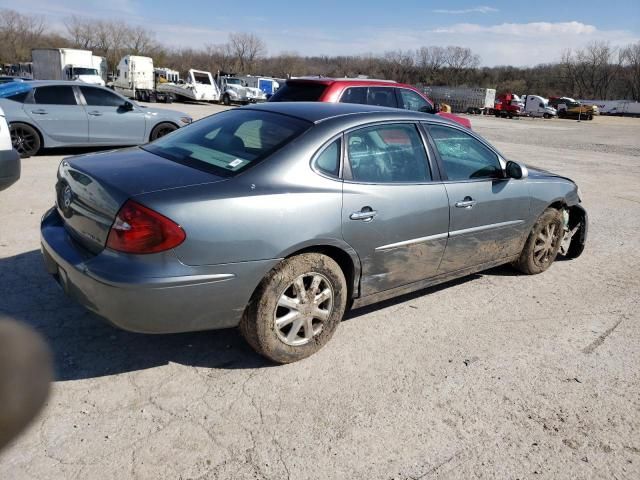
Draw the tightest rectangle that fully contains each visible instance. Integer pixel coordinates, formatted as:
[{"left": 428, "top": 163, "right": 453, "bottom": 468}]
[{"left": 0, "top": 80, "right": 192, "bottom": 157}]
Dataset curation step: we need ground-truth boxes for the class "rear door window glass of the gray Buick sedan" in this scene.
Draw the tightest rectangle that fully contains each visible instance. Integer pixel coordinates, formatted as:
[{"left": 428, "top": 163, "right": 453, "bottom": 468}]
[{"left": 347, "top": 124, "right": 431, "bottom": 183}]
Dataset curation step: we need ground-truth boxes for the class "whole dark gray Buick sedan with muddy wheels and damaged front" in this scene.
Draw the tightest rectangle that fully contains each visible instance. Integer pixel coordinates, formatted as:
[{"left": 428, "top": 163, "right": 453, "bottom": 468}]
[{"left": 41, "top": 103, "right": 587, "bottom": 363}]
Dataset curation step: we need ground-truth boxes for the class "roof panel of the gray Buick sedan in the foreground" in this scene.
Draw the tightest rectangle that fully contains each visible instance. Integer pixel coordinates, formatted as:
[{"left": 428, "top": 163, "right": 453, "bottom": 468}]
[{"left": 241, "top": 102, "right": 450, "bottom": 124}]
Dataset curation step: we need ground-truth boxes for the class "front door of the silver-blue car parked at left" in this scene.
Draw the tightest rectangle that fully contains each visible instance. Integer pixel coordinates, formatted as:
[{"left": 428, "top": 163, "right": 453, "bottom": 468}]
[{"left": 79, "top": 86, "right": 148, "bottom": 145}]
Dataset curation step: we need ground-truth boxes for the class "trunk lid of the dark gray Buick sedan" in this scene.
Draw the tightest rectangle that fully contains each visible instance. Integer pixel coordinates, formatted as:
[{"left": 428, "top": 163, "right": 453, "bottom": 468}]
[{"left": 56, "top": 148, "right": 225, "bottom": 253}]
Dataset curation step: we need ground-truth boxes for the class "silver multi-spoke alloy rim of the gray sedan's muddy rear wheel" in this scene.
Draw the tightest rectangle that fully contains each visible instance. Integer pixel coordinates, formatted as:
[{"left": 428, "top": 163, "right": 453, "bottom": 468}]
[{"left": 273, "top": 272, "right": 334, "bottom": 347}]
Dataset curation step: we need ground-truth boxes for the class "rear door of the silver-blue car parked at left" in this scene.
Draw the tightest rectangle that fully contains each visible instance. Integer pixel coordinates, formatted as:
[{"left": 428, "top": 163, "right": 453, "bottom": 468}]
[{"left": 23, "top": 85, "right": 89, "bottom": 145}]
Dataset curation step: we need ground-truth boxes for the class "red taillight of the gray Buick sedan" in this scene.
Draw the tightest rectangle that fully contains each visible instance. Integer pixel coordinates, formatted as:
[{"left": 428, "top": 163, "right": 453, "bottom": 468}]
[{"left": 107, "top": 200, "right": 187, "bottom": 254}]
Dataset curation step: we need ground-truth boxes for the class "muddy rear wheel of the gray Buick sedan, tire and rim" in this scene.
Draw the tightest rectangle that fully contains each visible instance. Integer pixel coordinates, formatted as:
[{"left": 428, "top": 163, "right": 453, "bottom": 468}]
[{"left": 240, "top": 253, "right": 348, "bottom": 363}]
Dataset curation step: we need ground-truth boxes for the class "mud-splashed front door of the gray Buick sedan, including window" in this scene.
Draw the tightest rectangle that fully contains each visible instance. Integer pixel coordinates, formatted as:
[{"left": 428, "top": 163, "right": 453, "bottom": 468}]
[{"left": 429, "top": 125, "right": 530, "bottom": 273}]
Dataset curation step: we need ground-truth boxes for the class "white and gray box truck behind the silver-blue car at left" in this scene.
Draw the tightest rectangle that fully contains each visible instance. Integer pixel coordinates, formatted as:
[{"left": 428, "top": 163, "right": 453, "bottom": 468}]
[{"left": 31, "top": 48, "right": 104, "bottom": 86}]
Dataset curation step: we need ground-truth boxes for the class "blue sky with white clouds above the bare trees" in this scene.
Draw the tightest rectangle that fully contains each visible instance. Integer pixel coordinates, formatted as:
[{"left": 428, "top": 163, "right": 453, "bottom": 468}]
[{"left": 0, "top": 0, "right": 640, "bottom": 66}]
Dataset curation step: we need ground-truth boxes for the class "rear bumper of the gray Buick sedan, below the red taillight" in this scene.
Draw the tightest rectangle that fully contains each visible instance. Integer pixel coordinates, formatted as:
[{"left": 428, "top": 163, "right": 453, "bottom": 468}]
[{"left": 41, "top": 209, "right": 278, "bottom": 333}]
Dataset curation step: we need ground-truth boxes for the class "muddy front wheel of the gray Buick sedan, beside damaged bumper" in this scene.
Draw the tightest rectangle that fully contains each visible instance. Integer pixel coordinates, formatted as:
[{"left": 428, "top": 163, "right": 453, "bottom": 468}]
[{"left": 513, "top": 208, "right": 564, "bottom": 275}]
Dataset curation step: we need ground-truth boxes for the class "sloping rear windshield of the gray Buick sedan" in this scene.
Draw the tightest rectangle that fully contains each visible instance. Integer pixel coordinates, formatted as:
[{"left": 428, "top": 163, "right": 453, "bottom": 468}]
[{"left": 142, "top": 109, "right": 311, "bottom": 176}]
